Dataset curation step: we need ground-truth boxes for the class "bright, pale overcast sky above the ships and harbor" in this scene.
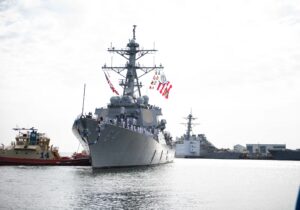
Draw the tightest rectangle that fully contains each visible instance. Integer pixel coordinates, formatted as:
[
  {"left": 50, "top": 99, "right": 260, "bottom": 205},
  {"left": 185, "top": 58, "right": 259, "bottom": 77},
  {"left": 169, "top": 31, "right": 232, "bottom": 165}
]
[{"left": 0, "top": 0, "right": 300, "bottom": 152}]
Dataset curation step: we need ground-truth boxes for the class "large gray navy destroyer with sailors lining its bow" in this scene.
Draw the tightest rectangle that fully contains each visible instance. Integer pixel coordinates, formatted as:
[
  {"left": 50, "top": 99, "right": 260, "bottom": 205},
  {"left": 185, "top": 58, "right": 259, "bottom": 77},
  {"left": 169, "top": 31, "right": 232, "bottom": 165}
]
[{"left": 72, "top": 25, "right": 175, "bottom": 168}]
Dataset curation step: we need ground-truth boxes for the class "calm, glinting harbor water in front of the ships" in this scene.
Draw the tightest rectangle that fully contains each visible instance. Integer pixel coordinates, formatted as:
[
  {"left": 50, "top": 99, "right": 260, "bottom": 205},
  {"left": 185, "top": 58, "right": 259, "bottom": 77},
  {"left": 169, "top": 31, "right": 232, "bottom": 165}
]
[{"left": 0, "top": 159, "right": 300, "bottom": 210}]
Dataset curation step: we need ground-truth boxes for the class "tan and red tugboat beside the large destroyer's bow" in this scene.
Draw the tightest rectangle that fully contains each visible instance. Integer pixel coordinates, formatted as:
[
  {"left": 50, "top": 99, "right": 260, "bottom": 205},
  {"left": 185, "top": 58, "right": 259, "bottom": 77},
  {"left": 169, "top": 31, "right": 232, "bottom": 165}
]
[{"left": 0, "top": 128, "right": 90, "bottom": 166}]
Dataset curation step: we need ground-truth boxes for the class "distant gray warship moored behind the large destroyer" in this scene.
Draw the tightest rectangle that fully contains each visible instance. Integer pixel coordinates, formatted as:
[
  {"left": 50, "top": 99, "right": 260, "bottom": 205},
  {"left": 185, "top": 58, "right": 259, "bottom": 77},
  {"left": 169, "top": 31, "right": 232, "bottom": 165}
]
[{"left": 175, "top": 114, "right": 243, "bottom": 159}]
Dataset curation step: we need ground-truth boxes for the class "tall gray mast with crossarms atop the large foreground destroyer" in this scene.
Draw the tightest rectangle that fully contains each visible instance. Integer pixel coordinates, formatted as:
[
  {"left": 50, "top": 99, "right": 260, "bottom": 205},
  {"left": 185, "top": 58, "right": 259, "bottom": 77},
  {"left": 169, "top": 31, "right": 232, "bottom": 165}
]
[{"left": 102, "top": 25, "right": 163, "bottom": 98}]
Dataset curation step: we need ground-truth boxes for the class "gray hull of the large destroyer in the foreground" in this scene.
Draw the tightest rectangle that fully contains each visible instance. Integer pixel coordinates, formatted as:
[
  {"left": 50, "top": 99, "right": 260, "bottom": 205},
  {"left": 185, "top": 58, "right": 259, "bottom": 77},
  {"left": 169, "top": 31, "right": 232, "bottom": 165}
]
[{"left": 73, "top": 118, "right": 175, "bottom": 168}]
